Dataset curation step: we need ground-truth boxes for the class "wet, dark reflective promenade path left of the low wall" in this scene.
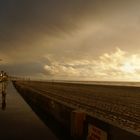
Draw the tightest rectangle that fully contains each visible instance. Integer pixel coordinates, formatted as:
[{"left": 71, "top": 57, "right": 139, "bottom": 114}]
[{"left": 0, "top": 82, "right": 57, "bottom": 140}]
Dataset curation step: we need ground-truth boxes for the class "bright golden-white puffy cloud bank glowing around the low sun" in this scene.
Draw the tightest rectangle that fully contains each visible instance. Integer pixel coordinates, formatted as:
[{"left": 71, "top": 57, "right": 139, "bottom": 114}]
[{"left": 44, "top": 48, "right": 140, "bottom": 81}]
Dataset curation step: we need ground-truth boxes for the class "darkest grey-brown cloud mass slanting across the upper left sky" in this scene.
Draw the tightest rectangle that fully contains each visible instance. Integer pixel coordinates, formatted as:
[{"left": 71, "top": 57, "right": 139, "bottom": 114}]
[{"left": 0, "top": 0, "right": 132, "bottom": 48}]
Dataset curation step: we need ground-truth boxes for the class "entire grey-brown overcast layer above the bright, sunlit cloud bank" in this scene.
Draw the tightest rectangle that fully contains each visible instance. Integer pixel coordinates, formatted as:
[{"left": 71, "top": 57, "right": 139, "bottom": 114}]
[{"left": 0, "top": 0, "right": 140, "bottom": 80}]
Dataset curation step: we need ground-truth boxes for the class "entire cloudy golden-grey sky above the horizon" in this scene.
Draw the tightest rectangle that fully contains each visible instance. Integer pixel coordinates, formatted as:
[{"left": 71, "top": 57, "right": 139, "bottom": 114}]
[{"left": 0, "top": 0, "right": 140, "bottom": 81}]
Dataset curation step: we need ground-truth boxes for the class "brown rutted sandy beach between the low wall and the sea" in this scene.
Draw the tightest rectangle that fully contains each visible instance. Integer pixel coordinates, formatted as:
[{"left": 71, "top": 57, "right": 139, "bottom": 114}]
[{"left": 13, "top": 81, "right": 140, "bottom": 135}]
